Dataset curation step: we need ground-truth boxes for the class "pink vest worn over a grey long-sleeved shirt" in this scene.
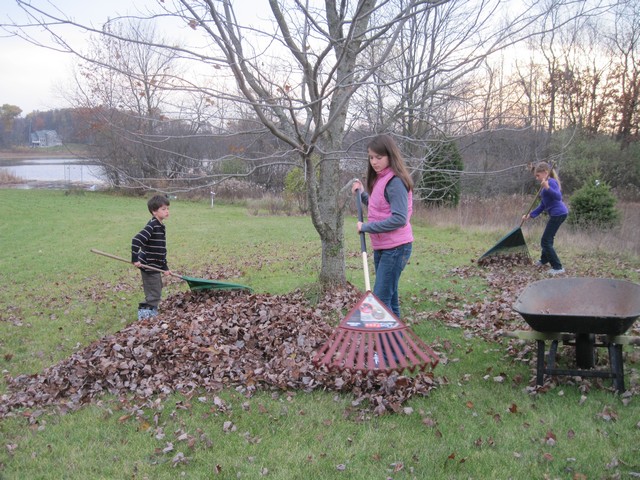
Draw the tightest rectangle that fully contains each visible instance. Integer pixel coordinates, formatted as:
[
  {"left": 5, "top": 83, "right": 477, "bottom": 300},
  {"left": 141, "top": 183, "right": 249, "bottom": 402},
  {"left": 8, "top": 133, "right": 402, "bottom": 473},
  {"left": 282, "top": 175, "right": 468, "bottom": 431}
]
[{"left": 367, "top": 168, "right": 413, "bottom": 250}]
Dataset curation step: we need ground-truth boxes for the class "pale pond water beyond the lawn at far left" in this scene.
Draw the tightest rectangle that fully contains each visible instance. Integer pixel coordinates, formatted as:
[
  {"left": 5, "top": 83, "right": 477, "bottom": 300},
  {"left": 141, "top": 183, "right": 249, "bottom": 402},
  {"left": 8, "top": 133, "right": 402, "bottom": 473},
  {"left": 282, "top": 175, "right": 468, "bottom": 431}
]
[{"left": 0, "top": 158, "right": 104, "bottom": 184}]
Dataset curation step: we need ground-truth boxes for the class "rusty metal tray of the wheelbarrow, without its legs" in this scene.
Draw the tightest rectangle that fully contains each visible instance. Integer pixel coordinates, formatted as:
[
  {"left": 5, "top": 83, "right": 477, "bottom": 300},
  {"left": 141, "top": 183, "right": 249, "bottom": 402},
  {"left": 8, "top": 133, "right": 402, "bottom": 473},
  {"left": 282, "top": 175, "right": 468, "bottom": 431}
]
[{"left": 513, "top": 278, "right": 640, "bottom": 335}]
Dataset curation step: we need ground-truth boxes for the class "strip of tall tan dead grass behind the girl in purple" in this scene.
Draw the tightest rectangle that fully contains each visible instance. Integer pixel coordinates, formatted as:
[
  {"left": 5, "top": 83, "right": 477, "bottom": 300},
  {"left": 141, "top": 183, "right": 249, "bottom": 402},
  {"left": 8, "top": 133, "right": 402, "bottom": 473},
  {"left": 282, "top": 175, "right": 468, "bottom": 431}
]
[{"left": 414, "top": 195, "right": 640, "bottom": 256}]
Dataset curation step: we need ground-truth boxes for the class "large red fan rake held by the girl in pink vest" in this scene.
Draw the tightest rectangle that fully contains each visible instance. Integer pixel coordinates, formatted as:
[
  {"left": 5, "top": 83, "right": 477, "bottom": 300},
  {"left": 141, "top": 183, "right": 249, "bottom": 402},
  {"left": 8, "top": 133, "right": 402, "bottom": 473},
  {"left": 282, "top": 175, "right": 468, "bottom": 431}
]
[{"left": 313, "top": 190, "right": 439, "bottom": 373}]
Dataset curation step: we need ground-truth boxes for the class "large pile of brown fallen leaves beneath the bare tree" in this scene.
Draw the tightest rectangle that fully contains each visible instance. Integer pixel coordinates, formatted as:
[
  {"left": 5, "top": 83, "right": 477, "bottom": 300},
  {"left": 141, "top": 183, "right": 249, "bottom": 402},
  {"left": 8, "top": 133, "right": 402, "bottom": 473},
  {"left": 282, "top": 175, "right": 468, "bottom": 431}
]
[{"left": 0, "top": 288, "right": 435, "bottom": 416}]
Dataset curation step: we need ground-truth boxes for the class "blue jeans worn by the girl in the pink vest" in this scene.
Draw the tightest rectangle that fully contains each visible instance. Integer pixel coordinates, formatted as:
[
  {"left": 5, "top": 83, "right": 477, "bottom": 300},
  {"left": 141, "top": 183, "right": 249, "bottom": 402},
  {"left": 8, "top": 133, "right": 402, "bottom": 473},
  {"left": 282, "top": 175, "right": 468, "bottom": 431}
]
[{"left": 373, "top": 243, "right": 412, "bottom": 318}]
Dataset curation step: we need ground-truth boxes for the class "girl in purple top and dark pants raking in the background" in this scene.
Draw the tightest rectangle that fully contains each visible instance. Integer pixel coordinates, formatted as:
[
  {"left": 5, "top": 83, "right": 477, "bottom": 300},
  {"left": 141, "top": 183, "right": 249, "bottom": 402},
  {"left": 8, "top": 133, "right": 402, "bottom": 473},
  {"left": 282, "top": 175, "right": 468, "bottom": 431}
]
[{"left": 522, "top": 162, "right": 569, "bottom": 275}]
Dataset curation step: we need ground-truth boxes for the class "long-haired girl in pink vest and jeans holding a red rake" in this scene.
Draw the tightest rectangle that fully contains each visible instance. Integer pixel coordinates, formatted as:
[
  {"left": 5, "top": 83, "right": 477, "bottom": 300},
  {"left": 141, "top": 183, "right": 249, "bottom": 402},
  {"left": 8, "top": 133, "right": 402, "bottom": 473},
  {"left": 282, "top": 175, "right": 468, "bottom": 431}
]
[{"left": 351, "top": 135, "right": 413, "bottom": 318}]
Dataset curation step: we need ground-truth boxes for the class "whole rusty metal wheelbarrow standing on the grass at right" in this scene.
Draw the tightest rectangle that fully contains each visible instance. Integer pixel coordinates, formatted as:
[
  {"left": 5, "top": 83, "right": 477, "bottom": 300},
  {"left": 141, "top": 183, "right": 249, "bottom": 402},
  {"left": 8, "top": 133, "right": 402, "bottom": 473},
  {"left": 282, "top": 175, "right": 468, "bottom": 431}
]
[{"left": 509, "top": 278, "right": 640, "bottom": 391}]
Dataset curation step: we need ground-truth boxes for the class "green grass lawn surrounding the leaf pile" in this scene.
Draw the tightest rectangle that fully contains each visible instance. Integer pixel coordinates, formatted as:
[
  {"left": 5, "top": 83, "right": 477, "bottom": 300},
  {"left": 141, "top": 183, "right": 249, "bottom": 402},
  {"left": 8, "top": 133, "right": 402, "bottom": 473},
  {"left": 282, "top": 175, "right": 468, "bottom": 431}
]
[{"left": 0, "top": 190, "right": 640, "bottom": 480}]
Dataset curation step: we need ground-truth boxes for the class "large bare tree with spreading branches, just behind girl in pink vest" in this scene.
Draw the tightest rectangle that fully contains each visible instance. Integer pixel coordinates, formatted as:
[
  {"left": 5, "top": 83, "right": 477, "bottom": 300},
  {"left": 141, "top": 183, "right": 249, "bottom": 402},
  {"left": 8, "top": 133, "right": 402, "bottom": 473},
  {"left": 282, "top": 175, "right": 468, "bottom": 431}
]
[{"left": 1, "top": 0, "right": 620, "bottom": 285}]
